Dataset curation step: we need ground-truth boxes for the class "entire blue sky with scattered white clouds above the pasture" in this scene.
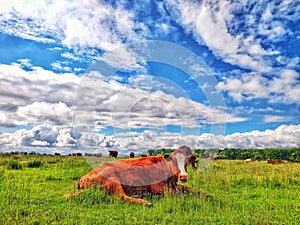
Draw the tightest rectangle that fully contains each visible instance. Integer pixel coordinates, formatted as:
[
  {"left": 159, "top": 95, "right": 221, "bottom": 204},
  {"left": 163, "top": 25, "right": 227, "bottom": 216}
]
[{"left": 0, "top": 0, "right": 300, "bottom": 152}]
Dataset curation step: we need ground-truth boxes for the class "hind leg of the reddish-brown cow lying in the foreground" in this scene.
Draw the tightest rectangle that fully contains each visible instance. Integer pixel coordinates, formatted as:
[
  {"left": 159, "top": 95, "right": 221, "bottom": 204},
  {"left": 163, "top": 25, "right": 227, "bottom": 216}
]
[{"left": 100, "top": 181, "right": 152, "bottom": 206}]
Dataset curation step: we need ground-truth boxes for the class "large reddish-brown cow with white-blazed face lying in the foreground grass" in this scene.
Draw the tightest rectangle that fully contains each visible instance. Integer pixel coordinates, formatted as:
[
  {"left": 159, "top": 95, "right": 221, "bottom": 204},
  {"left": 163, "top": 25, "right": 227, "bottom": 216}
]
[{"left": 67, "top": 149, "right": 209, "bottom": 206}]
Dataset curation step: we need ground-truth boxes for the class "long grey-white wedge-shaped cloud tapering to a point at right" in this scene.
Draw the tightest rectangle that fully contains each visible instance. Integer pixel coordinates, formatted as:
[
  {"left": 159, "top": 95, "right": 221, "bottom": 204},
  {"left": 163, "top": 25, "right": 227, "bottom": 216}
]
[{"left": 0, "top": 65, "right": 245, "bottom": 128}]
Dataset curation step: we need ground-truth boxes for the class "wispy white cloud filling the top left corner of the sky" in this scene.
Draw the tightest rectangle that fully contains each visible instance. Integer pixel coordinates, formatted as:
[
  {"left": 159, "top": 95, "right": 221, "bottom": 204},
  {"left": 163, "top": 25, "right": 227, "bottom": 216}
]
[{"left": 0, "top": 0, "right": 139, "bottom": 50}]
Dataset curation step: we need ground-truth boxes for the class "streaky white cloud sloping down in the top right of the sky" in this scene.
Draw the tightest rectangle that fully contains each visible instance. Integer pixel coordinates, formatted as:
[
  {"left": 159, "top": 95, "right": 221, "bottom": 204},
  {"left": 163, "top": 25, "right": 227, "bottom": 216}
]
[{"left": 167, "top": 0, "right": 300, "bottom": 72}]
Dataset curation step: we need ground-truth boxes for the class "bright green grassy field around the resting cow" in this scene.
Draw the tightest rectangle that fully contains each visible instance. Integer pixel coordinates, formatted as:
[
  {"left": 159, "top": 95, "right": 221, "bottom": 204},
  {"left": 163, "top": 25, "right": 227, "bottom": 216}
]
[{"left": 0, "top": 155, "right": 300, "bottom": 225}]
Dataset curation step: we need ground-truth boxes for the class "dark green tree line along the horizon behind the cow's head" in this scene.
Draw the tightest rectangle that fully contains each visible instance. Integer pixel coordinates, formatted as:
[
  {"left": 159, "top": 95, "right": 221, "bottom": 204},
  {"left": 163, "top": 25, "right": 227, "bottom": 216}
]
[{"left": 147, "top": 148, "right": 300, "bottom": 161}]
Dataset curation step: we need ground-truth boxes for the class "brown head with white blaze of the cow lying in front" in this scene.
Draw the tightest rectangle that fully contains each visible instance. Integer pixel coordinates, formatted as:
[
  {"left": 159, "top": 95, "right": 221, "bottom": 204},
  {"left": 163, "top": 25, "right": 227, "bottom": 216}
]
[{"left": 164, "top": 149, "right": 196, "bottom": 182}]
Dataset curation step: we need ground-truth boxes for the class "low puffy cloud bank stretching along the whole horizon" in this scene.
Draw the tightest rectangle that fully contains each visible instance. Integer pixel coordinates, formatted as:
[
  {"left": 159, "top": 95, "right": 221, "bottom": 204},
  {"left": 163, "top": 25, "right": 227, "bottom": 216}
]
[{"left": 0, "top": 125, "right": 300, "bottom": 153}]
